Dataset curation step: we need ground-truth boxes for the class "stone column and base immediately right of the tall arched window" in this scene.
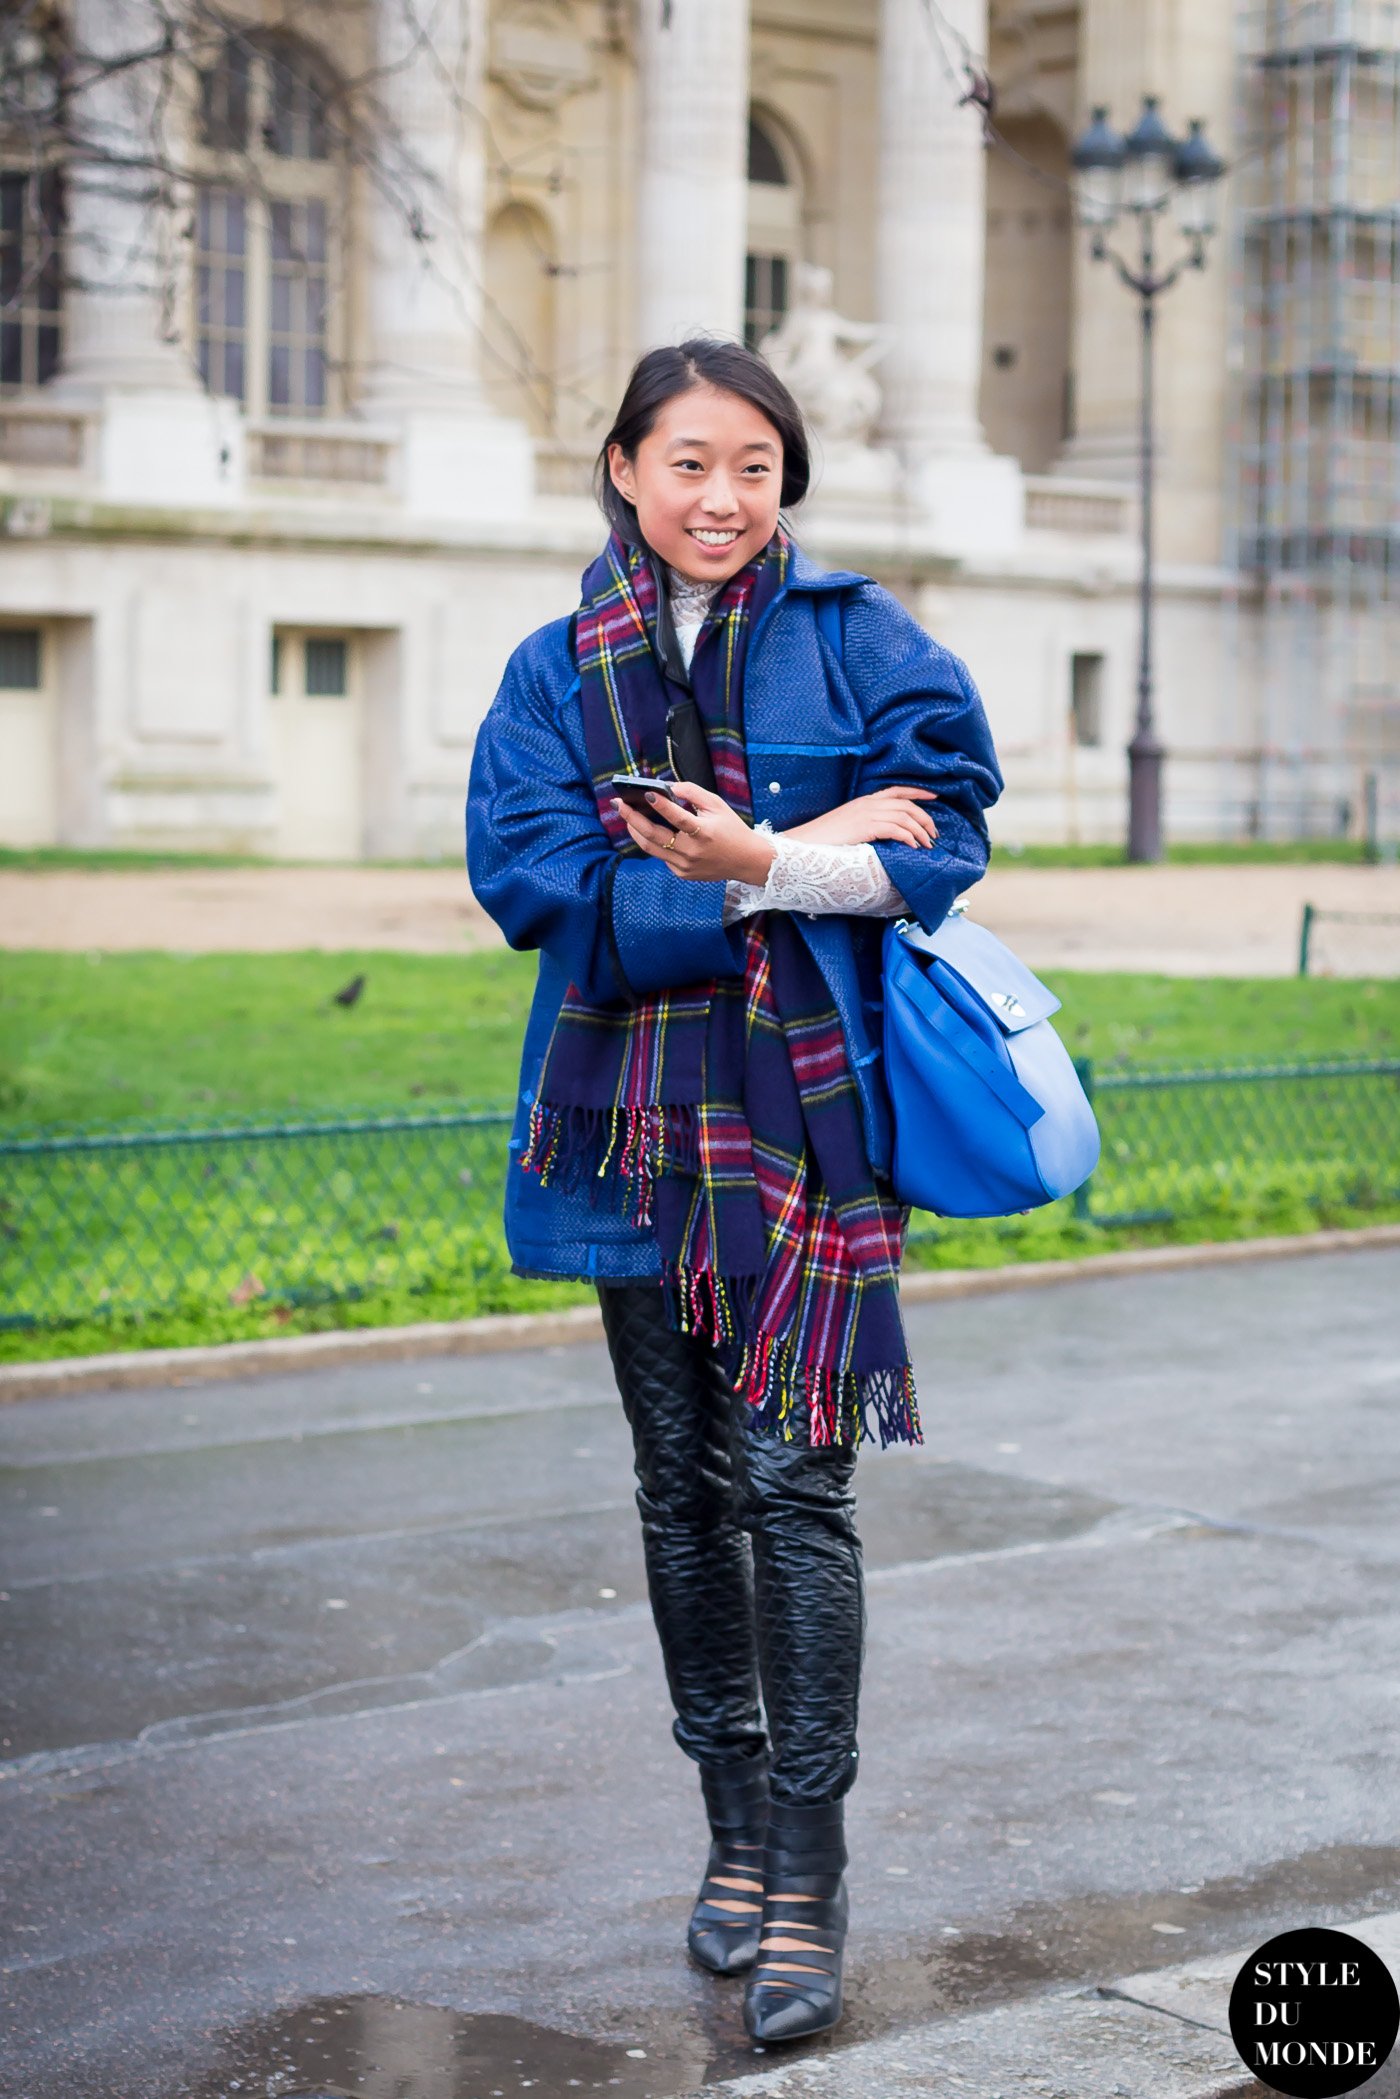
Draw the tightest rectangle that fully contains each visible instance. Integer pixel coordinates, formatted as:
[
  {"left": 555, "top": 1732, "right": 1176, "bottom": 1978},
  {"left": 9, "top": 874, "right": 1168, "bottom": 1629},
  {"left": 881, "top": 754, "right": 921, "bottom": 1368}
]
[{"left": 361, "top": 0, "right": 533, "bottom": 516}]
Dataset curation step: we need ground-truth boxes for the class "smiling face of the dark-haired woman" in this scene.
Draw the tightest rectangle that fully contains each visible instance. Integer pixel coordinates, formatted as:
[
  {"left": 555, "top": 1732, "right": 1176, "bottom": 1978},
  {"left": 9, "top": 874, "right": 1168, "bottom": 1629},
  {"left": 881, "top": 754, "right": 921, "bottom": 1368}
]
[{"left": 609, "top": 386, "right": 783, "bottom": 584}]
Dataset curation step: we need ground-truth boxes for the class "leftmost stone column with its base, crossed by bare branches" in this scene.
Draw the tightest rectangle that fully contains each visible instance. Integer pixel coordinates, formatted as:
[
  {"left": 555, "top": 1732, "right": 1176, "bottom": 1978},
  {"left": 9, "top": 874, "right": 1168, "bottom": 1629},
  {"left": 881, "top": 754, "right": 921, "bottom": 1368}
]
[{"left": 48, "top": 0, "right": 235, "bottom": 504}]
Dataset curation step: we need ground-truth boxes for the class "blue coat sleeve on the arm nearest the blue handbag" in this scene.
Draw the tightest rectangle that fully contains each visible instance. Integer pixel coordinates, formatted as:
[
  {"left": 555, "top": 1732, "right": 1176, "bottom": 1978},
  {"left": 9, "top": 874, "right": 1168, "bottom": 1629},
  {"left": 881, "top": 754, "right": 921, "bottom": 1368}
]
[{"left": 844, "top": 584, "right": 1001, "bottom": 932}]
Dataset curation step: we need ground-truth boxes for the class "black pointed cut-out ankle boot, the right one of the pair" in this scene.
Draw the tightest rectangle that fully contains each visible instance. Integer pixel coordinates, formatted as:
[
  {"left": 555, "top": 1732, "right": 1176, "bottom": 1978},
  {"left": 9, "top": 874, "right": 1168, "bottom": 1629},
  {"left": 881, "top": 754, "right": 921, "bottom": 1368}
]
[{"left": 743, "top": 1801, "right": 848, "bottom": 2042}]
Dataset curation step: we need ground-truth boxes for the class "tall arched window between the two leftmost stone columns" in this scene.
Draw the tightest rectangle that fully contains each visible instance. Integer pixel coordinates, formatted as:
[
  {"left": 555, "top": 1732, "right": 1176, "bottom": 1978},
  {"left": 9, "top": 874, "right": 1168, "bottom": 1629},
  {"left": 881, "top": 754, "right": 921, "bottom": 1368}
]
[{"left": 195, "top": 36, "right": 344, "bottom": 416}]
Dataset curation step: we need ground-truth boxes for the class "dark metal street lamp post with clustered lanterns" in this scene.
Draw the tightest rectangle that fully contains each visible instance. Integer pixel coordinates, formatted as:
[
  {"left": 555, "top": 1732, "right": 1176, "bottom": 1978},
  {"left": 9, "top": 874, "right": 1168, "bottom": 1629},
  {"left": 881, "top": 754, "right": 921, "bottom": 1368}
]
[{"left": 1070, "top": 94, "right": 1226, "bottom": 861}]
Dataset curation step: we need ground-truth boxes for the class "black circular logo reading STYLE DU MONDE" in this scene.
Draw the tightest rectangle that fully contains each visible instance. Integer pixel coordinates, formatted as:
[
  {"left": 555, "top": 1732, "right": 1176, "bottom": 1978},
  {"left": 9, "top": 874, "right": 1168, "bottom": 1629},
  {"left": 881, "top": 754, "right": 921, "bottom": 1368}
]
[{"left": 1230, "top": 1927, "right": 1400, "bottom": 2099}]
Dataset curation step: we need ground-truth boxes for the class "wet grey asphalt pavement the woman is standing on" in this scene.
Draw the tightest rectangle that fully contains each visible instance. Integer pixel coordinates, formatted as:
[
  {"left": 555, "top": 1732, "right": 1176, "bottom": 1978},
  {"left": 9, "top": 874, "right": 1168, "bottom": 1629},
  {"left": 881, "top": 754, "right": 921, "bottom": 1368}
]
[{"left": 0, "top": 1253, "right": 1400, "bottom": 2099}]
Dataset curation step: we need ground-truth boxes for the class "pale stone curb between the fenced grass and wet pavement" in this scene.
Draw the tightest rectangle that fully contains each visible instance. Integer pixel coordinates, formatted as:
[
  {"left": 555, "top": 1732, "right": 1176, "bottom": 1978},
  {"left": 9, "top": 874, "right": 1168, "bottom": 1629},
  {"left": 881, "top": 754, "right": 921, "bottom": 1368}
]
[{"left": 0, "top": 1224, "right": 1400, "bottom": 1402}]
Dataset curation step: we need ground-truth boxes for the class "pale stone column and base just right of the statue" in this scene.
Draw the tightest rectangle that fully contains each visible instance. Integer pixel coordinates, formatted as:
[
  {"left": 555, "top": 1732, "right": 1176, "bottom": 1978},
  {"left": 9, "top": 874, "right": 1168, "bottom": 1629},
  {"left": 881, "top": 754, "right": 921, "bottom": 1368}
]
[{"left": 877, "top": 0, "right": 1020, "bottom": 548}]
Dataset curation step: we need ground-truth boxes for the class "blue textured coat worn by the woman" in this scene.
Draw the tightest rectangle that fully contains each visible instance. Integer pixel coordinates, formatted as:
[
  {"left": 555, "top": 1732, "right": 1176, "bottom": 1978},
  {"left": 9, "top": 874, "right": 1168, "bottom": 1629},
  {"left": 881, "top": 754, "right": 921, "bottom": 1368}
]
[{"left": 466, "top": 548, "right": 1001, "bottom": 1278}]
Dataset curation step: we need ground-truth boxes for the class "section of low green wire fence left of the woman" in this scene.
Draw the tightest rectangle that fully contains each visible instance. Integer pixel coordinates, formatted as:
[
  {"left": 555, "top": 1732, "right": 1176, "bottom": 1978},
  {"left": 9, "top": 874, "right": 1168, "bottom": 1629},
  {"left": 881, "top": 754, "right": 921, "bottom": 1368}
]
[{"left": 0, "top": 1108, "right": 510, "bottom": 1327}]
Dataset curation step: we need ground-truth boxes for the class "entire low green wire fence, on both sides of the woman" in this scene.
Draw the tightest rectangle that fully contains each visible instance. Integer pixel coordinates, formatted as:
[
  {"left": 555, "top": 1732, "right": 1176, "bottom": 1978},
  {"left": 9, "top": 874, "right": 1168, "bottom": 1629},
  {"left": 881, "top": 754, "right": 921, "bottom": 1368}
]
[{"left": 0, "top": 1058, "right": 1400, "bottom": 1329}]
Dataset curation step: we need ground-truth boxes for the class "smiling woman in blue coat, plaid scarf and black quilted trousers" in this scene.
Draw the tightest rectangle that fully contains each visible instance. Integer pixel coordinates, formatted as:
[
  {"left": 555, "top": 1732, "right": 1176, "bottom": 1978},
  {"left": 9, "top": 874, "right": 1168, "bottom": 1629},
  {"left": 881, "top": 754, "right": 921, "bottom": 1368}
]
[{"left": 468, "top": 340, "right": 1001, "bottom": 2042}]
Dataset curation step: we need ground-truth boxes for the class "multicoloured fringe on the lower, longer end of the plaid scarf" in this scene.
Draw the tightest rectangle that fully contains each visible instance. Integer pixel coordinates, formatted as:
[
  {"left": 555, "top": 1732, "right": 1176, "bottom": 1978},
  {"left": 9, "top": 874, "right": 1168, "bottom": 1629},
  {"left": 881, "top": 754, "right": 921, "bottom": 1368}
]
[{"left": 663, "top": 1266, "right": 924, "bottom": 1450}]
